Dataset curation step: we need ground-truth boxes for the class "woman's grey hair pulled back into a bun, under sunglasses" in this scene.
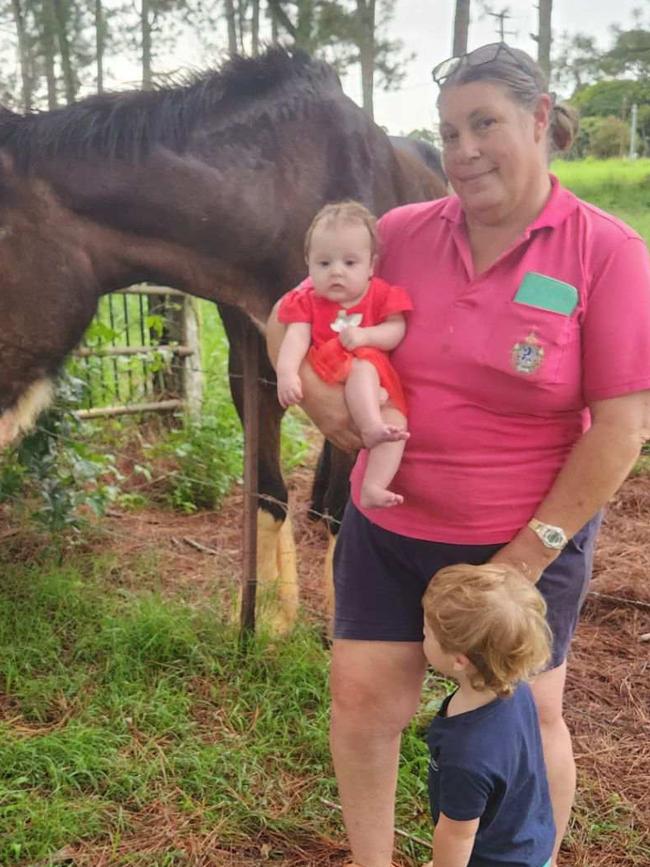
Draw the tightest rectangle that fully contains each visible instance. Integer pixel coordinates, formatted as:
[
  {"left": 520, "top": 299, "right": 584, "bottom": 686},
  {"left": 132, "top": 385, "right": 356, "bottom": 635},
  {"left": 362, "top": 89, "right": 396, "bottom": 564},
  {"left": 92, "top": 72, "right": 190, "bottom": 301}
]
[{"left": 440, "top": 43, "right": 578, "bottom": 151}]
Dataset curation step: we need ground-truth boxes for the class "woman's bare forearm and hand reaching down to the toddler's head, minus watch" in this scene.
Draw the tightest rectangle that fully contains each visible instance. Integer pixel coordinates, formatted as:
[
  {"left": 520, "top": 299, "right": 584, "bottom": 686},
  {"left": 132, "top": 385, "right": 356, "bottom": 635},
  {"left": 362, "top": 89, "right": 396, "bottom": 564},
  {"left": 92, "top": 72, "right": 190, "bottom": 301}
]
[{"left": 492, "top": 391, "right": 650, "bottom": 581}]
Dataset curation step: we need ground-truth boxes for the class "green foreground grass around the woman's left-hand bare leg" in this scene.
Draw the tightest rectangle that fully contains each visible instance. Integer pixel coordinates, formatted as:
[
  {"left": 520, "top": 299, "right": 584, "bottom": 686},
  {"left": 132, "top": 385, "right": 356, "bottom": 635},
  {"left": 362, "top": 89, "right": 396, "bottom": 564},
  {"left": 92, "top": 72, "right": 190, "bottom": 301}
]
[{"left": 0, "top": 554, "right": 440, "bottom": 865}]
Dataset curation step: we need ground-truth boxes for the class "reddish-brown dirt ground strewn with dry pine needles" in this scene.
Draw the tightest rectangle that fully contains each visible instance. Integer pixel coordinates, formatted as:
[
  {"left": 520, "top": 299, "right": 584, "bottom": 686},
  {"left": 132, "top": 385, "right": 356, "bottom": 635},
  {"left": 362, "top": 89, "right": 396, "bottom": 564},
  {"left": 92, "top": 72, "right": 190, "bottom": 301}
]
[{"left": 59, "top": 469, "right": 650, "bottom": 867}]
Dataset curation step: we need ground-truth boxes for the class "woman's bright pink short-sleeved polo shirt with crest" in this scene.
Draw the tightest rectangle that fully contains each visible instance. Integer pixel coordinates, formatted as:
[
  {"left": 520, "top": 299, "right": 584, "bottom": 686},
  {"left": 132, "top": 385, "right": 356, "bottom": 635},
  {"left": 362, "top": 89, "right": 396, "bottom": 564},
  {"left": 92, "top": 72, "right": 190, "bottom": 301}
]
[{"left": 352, "top": 178, "right": 650, "bottom": 544}]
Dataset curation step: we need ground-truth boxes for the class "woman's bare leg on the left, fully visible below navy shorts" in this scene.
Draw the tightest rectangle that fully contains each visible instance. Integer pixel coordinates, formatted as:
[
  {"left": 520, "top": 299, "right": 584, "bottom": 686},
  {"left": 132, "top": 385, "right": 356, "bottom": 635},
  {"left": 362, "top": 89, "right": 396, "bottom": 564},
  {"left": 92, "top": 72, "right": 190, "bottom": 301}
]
[{"left": 330, "top": 639, "right": 425, "bottom": 867}]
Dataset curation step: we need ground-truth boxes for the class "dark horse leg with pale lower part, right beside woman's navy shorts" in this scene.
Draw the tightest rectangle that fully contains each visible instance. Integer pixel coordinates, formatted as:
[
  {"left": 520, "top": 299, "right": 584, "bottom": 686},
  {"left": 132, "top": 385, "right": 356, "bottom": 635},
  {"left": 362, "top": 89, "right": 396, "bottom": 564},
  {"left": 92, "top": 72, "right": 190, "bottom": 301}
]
[{"left": 310, "top": 440, "right": 355, "bottom": 617}]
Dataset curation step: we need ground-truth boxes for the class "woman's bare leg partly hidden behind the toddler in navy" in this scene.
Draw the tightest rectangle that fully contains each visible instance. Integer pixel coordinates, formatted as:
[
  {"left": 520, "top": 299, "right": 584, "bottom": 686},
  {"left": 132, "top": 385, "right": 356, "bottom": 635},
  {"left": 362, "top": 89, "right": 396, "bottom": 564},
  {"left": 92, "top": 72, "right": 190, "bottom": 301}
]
[{"left": 531, "top": 662, "right": 576, "bottom": 865}]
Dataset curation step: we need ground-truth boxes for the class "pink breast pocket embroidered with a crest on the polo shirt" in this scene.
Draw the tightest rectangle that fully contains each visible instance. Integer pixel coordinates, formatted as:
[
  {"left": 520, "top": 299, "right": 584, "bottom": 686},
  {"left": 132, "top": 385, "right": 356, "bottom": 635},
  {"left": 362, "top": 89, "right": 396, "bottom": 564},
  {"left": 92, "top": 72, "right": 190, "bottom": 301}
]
[{"left": 481, "top": 301, "right": 577, "bottom": 387}]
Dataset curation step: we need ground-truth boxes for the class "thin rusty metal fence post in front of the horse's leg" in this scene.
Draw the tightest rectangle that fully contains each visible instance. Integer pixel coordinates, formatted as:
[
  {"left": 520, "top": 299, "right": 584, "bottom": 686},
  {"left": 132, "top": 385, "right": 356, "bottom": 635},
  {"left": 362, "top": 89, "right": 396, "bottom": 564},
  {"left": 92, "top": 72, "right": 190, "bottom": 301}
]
[{"left": 240, "top": 320, "right": 259, "bottom": 639}]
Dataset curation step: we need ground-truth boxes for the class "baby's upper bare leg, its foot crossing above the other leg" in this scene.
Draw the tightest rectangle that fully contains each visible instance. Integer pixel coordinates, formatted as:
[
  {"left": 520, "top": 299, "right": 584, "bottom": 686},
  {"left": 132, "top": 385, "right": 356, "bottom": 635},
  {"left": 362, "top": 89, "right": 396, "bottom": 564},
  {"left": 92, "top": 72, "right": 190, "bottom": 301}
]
[{"left": 345, "top": 358, "right": 408, "bottom": 448}]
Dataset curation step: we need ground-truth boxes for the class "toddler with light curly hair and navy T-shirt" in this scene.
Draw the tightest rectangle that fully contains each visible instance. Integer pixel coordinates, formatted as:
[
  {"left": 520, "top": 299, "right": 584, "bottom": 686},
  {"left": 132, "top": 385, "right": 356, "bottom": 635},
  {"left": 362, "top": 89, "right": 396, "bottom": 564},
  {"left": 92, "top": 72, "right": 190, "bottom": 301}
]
[{"left": 422, "top": 563, "right": 555, "bottom": 867}]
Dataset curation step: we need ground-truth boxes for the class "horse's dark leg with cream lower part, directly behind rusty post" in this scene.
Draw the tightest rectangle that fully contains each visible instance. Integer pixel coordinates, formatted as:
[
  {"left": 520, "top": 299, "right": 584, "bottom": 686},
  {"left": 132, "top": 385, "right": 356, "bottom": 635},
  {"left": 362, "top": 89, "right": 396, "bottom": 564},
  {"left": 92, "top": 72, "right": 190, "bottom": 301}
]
[{"left": 217, "top": 304, "right": 298, "bottom": 633}]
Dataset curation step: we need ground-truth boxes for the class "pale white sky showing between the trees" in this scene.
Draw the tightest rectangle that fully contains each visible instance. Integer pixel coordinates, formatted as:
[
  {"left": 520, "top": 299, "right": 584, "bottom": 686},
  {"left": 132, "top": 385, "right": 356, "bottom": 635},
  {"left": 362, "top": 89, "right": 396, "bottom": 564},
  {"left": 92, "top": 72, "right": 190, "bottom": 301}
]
[{"left": 109, "top": 0, "right": 636, "bottom": 134}]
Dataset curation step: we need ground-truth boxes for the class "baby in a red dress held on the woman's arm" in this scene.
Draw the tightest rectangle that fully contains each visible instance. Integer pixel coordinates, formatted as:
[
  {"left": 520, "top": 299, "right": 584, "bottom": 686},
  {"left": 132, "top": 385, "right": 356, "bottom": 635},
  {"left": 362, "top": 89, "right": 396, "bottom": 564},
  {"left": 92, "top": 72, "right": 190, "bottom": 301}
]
[{"left": 277, "top": 202, "right": 413, "bottom": 509}]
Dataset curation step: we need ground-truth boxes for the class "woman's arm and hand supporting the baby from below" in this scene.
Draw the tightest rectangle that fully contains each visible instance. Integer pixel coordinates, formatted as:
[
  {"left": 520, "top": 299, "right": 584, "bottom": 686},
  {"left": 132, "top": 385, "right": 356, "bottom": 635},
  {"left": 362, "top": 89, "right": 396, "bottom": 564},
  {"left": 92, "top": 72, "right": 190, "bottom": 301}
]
[{"left": 266, "top": 302, "right": 363, "bottom": 452}]
